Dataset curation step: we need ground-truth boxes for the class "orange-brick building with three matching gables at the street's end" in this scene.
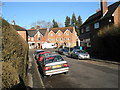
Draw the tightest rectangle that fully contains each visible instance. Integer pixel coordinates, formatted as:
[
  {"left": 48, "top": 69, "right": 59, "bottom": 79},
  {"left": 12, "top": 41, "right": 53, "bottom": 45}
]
[{"left": 48, "top": 27, "right": 78, "bottom": 47}]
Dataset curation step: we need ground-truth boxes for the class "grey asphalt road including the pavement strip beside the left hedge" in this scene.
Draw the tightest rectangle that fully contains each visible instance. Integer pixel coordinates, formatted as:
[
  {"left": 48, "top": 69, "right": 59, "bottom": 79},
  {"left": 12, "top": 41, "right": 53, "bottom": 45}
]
[{"left": 29, "top": 50, "right": 118, "bottom": 88}]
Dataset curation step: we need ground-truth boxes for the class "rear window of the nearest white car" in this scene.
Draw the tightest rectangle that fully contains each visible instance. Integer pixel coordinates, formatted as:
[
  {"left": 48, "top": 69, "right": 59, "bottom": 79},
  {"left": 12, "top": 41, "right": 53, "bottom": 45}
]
[{"left": 45, "top": 56, "right": 64, "bottom": 64}]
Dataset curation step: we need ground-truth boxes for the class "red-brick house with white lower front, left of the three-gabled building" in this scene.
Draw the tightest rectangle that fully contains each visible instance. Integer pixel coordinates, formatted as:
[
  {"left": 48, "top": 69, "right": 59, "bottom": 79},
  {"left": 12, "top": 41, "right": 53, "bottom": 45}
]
[{"left": 27, "top": 28, "right": 48, "bottom": 49}]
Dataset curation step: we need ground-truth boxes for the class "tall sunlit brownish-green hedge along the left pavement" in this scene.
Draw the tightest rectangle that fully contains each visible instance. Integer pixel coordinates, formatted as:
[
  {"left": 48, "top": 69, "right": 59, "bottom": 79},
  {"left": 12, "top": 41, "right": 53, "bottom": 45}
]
[{"left": 1, "top": 19, "right": 28, "bottom": 88}]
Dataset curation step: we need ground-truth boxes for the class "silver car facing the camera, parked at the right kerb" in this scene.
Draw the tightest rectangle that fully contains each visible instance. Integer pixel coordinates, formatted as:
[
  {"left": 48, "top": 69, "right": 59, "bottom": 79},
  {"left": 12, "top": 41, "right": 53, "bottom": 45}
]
[{"left": 71, "top": 49, "right": 90, "bottom": 59}]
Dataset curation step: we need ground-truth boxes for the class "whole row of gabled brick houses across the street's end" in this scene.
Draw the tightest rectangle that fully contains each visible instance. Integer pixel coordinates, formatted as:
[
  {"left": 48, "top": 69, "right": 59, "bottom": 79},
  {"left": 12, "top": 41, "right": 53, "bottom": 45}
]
[{"left": 27, "top": 27, "right": 79, "bottom": 49}]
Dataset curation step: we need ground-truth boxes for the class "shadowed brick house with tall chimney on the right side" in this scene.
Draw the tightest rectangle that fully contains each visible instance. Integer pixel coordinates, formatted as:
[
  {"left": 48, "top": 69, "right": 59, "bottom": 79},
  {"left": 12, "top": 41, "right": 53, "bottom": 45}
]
[{"left": 79, "top": 0, "right": 120, "bottom": 48}]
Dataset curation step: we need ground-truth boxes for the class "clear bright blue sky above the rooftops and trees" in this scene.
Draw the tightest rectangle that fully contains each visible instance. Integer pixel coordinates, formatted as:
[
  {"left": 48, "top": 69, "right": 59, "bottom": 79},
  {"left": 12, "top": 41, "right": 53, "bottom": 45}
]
[{"left": 2, "top": 2, "right": 114, "bottom": 29}]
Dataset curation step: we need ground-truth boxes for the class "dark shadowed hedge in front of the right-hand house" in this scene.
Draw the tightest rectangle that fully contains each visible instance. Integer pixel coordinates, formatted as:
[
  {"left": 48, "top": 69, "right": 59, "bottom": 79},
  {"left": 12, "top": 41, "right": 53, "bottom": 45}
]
[{"left": 96, "top": 26, "right": 120, "bottom": 61}]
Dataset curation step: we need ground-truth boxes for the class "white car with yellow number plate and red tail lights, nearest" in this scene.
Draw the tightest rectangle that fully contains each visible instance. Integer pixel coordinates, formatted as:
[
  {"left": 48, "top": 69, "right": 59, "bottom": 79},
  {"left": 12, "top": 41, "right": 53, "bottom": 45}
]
[{"left": 41, "top": 55, "right": 69, "bottom": 76}]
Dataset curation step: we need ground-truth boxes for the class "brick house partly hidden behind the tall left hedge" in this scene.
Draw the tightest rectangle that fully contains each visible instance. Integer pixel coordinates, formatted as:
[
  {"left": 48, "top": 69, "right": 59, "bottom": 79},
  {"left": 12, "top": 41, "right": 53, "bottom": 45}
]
[{"left": 12, "top": 20, "right": 28, "bottom": 41}]
